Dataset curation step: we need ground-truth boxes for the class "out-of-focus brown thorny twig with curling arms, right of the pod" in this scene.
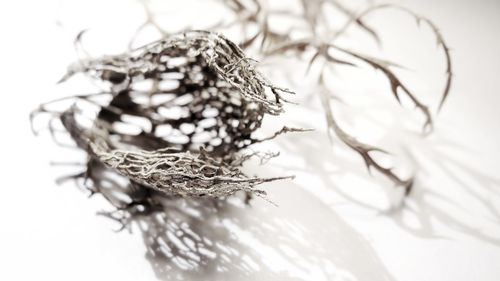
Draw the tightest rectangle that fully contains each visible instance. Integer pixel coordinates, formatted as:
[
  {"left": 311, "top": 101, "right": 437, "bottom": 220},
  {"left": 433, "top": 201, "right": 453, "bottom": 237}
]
[{"left": 207, "top": 0, "right": 452, "bottom": 194}]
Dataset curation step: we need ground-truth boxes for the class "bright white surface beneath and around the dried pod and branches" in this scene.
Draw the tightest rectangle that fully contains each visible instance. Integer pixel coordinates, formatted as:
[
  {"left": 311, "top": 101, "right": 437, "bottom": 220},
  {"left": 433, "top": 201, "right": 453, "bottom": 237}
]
[{"left": 0, "top": 0, "right": 500, "bottom": 281}]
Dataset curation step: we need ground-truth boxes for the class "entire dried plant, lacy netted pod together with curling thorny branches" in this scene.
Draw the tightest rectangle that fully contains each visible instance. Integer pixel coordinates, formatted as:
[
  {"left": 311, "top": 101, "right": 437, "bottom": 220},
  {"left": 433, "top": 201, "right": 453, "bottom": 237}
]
[{"left": 32, "top": 0, "right": 452, "bottom": 221}]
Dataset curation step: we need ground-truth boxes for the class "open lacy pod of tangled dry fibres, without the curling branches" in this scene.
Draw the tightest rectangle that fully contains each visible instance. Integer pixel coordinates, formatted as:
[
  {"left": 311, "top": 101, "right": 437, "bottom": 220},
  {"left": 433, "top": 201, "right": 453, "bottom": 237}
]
[{"left": 35, "top": 31, "right": 300, "bottom": 197}]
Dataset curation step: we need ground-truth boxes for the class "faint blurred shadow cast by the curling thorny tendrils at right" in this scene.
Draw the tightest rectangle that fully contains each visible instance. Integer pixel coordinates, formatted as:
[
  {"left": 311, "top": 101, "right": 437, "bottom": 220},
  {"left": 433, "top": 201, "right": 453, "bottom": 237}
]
[{"left": 279, "top": 121, "right": 500, "bottom": 247}]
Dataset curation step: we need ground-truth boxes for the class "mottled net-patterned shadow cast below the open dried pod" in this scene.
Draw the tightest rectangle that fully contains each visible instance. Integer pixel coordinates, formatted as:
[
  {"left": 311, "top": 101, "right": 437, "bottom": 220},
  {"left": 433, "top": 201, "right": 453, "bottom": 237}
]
[{"left": 64, "top": 160, "right": 394, "bottom": 280}]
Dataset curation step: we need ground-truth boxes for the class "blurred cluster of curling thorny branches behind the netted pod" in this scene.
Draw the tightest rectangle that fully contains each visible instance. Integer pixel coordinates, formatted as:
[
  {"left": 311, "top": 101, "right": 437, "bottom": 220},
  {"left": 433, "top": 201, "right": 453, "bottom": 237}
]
[{"left": 200, "top": 0, "right": 452, "bottom": 193}]
